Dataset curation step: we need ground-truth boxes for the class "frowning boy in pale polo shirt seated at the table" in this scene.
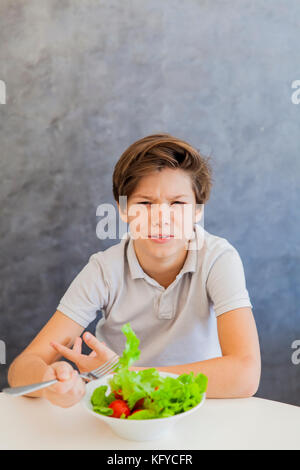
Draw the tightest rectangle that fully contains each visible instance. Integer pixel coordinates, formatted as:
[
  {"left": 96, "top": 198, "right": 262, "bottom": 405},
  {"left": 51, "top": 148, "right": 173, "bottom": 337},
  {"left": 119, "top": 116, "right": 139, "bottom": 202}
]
[{"left": 8, "top": 134, "right": 261, "bottom": 407}]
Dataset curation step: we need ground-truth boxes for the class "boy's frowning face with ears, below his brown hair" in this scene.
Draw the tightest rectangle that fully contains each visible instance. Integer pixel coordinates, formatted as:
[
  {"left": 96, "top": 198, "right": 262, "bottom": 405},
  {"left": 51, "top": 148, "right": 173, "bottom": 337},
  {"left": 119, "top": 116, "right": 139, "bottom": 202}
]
[{"left": 119, "top": 168, "right": 202, "bottom": 257}]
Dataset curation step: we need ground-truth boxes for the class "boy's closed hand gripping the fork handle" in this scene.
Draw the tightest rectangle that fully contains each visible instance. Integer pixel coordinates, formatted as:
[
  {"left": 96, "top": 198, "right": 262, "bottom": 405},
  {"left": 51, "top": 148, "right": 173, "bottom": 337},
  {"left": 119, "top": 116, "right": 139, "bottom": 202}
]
[{"left": 42, "top": 361, "right": 85, "bottom": 408}]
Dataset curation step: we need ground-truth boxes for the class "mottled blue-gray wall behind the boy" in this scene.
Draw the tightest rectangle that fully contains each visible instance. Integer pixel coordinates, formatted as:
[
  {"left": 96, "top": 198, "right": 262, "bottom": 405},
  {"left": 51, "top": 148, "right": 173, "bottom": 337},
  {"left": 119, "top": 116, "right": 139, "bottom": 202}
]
[{"left": 0, "top": 0, "right": 300, "bottom": 405}]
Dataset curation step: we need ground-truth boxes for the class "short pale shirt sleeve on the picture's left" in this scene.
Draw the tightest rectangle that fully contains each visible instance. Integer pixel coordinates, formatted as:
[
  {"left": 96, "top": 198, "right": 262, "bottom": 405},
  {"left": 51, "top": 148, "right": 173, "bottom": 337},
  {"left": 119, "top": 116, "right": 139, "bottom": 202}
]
[{"left": 57, "top": 253, "right": 109, "bottom": 328}]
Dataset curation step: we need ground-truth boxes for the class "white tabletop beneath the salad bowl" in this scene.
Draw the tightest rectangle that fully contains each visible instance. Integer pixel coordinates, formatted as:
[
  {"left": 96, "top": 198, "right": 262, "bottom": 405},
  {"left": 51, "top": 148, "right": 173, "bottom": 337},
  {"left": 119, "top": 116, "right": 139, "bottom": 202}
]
[{"left": 0, "top": 393, "right": 300, "bottom": 450}]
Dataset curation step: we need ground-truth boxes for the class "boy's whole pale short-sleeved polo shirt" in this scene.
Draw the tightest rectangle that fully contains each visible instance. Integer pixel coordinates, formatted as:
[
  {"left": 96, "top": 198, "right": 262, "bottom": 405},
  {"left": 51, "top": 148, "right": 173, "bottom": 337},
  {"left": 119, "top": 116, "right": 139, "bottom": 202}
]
[{"left": 57, "top": 224, "right": 252, "bottom": 367}]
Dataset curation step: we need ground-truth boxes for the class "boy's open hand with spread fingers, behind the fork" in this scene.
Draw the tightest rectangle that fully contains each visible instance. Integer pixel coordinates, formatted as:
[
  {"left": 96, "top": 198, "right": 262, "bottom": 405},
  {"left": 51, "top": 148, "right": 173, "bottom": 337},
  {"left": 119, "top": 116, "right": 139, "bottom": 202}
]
[{"left": 50, "top": 332, "right": 116, "bottom": 372}]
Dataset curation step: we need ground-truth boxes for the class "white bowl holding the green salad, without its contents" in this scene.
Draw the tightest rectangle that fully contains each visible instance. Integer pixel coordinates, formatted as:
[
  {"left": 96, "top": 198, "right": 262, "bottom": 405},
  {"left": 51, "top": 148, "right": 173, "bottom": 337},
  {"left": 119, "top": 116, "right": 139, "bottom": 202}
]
[{"left": 81, "top": 372, "right": 206, "bottom": 441}]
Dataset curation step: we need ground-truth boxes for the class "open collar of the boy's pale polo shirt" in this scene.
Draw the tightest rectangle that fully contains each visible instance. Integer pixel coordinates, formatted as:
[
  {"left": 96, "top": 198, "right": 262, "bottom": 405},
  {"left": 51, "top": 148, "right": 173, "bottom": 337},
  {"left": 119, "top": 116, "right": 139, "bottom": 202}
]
[{"left": 127, "top": 224, "right": 200, "bottom": 279}]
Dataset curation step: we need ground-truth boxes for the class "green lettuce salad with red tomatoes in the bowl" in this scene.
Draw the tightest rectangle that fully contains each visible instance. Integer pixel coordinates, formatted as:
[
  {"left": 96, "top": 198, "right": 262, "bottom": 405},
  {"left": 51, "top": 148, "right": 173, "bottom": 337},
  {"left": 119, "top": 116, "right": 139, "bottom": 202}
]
[{"left": 91, "top": 323, "right": 207, "bottom": 419}]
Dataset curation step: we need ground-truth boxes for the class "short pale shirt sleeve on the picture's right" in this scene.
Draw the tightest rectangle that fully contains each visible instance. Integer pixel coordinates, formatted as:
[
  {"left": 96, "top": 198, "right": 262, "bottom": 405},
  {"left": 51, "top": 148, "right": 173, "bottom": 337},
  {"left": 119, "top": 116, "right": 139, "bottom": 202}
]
[{"left": 206, "top": 247, "right": 252, "bottom": 316}]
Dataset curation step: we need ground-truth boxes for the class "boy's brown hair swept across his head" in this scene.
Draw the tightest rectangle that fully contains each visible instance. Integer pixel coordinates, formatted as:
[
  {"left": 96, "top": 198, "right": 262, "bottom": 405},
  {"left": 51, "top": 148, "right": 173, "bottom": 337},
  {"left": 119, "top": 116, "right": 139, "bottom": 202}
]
[{"left": 113, "top": 133, "right": 212, "bottom": 204}]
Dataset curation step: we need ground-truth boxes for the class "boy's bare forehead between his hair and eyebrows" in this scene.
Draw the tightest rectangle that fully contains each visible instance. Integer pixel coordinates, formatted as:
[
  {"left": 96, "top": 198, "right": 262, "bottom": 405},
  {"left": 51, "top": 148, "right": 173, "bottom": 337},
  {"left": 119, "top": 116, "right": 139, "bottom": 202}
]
[{"left": 132, "top": 168, "right": 193, "bottom": 197}]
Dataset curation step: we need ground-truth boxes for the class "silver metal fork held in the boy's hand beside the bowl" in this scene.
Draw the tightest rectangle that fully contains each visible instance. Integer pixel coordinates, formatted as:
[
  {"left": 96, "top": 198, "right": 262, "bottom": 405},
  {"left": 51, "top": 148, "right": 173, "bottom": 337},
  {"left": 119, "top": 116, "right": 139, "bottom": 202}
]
[{"left": 2, "top": 355, "right": 120, "bottom": 397}]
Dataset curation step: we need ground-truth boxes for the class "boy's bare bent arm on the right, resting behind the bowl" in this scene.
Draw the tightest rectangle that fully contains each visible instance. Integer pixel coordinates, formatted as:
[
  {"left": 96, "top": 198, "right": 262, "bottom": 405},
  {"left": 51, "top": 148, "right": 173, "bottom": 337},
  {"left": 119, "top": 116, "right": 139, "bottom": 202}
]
[{"left": 132, "top": 307, "right": 261, "bottom": 398}]
